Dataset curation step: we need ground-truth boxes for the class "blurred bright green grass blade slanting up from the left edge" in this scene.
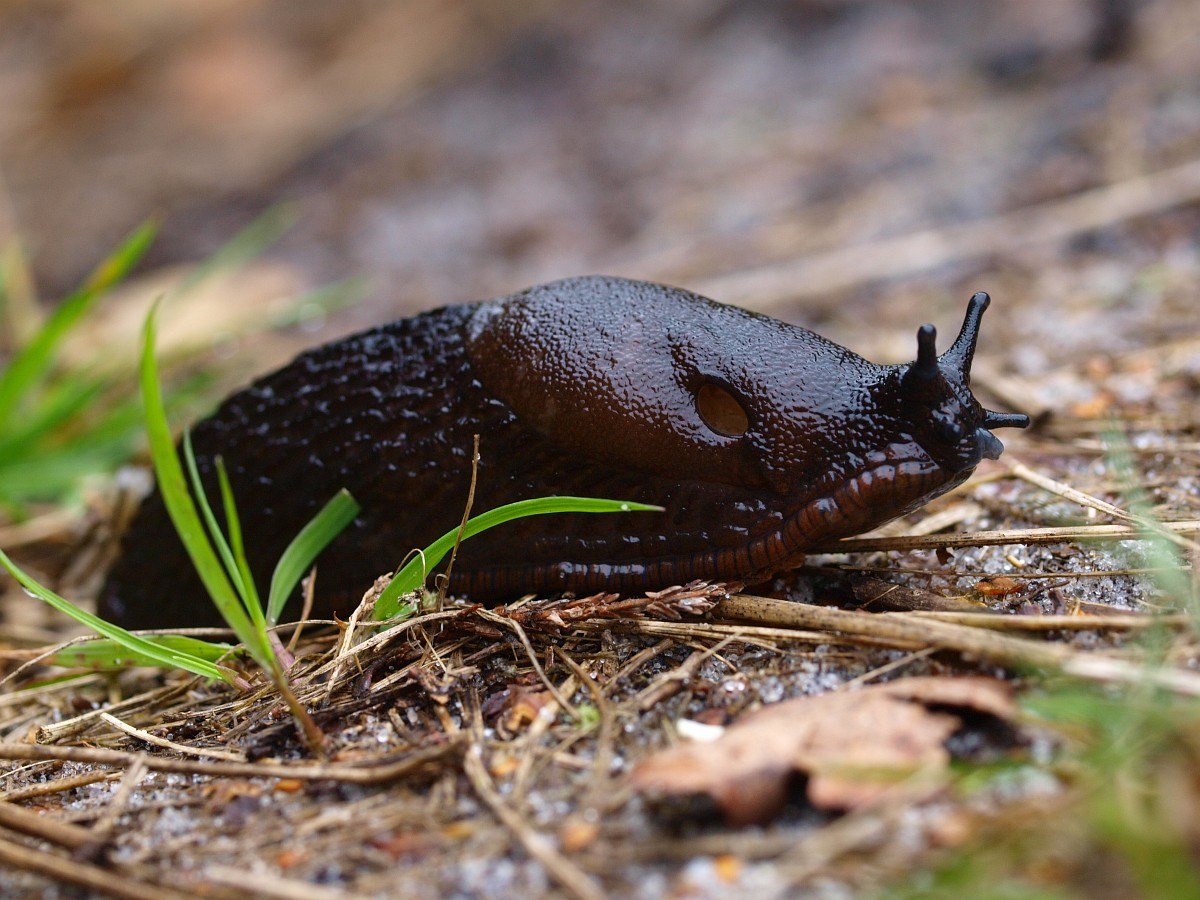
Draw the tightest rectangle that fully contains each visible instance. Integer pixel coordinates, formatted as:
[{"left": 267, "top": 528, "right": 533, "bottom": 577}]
[{"left": 0, "top": 223, "right": 155, "bottom": 430}]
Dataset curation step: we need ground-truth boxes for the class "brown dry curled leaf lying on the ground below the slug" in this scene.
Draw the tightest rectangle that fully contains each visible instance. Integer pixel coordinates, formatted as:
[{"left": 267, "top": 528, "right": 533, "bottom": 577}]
[{"left": 632, "top": 677, "right": 1015, "bottom": 826}]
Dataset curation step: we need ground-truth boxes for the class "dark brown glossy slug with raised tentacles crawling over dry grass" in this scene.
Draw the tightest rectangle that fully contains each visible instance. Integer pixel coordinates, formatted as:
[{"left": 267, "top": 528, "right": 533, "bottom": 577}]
[{"left": 101, "top": 277, "right": 1028, "bottom": 628}]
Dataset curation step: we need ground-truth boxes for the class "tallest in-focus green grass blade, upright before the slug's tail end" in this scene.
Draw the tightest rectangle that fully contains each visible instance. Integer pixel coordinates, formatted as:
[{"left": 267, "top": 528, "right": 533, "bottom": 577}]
[{"left": 140, "top": 306, "right": 266, "bottom": 671}]
